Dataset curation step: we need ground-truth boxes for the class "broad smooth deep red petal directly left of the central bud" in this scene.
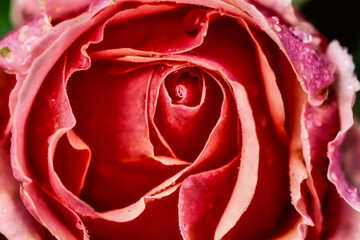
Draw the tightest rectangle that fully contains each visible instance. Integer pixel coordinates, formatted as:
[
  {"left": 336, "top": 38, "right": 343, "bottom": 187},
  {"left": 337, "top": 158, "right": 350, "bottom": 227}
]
[{"left": 67, "top": 61, "right": 184, "bottom": 211}]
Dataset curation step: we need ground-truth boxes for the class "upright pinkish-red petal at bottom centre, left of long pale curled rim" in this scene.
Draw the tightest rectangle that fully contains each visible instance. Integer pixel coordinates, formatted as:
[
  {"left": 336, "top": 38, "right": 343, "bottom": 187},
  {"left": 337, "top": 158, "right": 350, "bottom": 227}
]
[{"left": 178, "top": 158, "right": 239, "bottom": 239}]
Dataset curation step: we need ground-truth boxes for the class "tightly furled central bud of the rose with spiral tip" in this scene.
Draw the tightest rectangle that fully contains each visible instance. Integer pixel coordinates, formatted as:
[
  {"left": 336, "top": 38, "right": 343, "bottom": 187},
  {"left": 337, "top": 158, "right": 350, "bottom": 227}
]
[{"left": 154, "top": 69, "right": 223, "bottom": 161}]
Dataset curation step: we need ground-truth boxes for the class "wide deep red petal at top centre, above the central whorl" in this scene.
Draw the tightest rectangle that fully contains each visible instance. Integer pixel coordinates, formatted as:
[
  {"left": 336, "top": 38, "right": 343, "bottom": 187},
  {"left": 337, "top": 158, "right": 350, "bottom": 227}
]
[{"left": 89, "top": 5, "right": 211, "bottom": 58}]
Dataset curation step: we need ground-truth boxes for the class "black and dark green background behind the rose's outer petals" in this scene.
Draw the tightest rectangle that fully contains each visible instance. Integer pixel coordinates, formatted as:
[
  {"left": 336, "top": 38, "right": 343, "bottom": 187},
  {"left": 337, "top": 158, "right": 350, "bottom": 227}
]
[{"left": 0, "top": 0, "right": 360, "bottom": 115}]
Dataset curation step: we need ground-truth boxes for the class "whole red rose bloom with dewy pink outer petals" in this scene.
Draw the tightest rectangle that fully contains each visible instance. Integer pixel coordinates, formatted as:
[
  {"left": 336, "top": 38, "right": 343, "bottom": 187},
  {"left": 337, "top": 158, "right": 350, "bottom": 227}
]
[{"left": 0, "top": 0, "right": 360, "bottom": 239}]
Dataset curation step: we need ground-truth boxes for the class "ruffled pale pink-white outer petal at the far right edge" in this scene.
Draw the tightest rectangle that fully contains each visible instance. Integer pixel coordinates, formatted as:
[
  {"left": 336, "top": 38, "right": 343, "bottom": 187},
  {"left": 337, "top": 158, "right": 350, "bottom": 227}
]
[{"left": 328, "top": 42, "right": 360, "bottom": 212}]
